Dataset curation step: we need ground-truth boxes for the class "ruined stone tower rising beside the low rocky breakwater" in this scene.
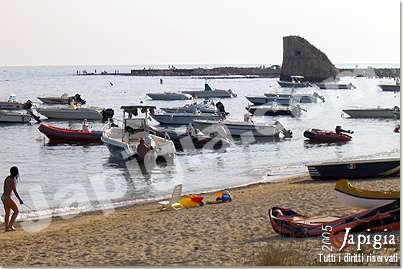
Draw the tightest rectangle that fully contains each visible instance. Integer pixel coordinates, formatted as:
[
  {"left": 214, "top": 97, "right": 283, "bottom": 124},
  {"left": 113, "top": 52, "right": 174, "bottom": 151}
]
[{"left": 280, "top": 36, "right": 338, "bottom": 82}]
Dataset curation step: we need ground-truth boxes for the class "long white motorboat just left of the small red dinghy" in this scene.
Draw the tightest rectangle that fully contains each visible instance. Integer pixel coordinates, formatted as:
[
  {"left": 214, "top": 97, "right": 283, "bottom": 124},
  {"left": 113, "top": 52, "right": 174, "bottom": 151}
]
[{"left": 192, "top": 120, "right": 292, "bottom": 137}]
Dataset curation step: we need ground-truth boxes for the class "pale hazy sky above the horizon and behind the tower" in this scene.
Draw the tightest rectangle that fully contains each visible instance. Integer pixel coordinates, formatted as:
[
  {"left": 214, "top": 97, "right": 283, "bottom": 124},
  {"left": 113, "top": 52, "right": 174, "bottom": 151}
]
[{"left": 0, "top": 0, "right": 400, "bottom": 66}]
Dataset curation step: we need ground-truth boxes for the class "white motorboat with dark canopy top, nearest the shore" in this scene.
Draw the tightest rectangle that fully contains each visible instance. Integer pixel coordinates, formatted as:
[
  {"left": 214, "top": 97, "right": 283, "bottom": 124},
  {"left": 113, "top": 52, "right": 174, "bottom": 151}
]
[{"left": 101, "top": 106, "right": 176, "bottom": 163}]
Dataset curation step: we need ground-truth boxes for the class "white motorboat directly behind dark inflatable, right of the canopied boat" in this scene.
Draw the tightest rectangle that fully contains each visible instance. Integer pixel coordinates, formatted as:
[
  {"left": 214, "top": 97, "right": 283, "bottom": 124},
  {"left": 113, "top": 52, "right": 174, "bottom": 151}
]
[{"left": 151, "top": 112, "right": 225, "bottom": 125}]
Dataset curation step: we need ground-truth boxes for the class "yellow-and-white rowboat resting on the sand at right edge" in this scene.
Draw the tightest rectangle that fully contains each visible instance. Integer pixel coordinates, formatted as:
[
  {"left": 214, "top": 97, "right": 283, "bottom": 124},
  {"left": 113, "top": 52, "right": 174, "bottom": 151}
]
[{"left": 334, "top": 179, "right": 400, "bottom": 208}]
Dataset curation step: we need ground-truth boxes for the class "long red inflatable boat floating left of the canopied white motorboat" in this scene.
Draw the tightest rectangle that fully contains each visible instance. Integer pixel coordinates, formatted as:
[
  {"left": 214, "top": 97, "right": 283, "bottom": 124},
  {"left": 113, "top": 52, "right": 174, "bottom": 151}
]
[{"left": 38, "top": 124, "right": 102, "bottom": 143}]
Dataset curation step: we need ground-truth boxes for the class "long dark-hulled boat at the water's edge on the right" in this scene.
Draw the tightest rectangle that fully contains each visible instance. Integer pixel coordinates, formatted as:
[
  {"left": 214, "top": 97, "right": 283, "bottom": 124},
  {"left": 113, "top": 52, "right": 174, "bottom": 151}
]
[{"left": 307, "top": 158, "right": 400, "bottom": 179}]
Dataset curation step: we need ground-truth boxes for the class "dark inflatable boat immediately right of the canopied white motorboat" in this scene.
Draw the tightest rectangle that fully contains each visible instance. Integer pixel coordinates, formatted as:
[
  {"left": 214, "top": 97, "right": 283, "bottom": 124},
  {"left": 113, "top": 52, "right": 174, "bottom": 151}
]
[{"left": 149, "top": 127, "right": 231, "bottom": 151}]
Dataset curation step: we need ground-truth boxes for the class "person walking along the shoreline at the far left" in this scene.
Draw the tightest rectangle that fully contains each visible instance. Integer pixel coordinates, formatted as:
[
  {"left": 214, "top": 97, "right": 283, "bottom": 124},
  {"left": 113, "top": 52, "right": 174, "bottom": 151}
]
[{"left": 1, "top": 166, "right": 23, "bottom": 232}]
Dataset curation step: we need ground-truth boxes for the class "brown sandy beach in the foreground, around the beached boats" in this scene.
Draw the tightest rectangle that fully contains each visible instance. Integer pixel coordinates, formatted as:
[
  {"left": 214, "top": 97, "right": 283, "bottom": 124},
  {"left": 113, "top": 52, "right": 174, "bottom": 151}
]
[{"left": 0, "top": 177, "right": 400, "bottom": 266}]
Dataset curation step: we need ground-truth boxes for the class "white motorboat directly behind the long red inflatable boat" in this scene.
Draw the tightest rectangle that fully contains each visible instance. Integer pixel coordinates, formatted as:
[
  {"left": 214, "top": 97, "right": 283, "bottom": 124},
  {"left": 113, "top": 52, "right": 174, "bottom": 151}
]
[{"left": 36, "top": 107, "right": 114, "bottom": 120}]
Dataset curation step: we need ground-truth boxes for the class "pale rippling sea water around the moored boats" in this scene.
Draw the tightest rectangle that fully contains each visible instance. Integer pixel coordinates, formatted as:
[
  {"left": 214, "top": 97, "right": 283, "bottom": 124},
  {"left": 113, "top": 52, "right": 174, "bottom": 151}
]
[{"left": 0, "top": 66, "right": 400, "bottom": 220}]
